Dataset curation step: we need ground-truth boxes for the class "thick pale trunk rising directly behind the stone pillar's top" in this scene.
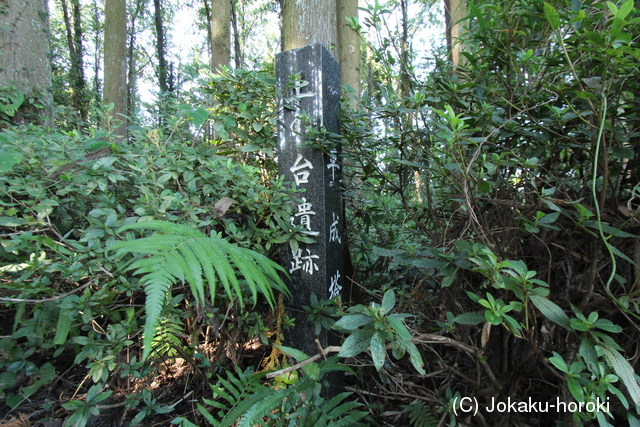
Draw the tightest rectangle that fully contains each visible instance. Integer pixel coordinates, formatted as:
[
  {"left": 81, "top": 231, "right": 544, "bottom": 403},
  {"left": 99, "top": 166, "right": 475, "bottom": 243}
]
[{"left": 282, "top": 0, "right": 338, "bottom": 52}]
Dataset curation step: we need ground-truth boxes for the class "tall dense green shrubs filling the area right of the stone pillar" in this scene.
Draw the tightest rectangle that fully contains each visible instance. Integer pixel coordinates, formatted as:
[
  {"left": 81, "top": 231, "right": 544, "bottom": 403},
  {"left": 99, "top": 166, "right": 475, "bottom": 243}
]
[{"left": 343, "top": 1, "right": 640, "bottom": 425}]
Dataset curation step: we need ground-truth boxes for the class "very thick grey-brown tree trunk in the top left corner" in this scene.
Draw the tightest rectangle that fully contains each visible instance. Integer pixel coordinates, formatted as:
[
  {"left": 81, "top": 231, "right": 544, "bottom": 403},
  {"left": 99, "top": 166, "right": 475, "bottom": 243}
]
[{"left": 0, "top": 0, "right": 53, "bottom": 125}]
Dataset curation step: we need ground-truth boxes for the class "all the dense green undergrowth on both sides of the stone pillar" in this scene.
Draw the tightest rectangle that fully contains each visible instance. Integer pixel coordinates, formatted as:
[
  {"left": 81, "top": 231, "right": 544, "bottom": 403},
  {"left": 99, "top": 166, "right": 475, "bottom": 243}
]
[{"left": 0, "top": 0, "right": 640, "bottom": 426}]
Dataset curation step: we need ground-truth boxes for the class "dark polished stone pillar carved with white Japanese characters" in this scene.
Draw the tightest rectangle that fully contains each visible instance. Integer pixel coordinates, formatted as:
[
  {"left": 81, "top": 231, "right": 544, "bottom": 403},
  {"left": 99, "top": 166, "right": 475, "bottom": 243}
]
[{"left": 276, "top": 44, "right": 344, "bottom": 355}]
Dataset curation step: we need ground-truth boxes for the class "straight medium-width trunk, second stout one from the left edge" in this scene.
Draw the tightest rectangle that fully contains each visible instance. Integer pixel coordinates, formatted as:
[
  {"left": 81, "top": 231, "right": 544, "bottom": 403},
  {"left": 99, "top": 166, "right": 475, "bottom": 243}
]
[{"left": 104, "top": 0, "right": 127, "bottom": 142}]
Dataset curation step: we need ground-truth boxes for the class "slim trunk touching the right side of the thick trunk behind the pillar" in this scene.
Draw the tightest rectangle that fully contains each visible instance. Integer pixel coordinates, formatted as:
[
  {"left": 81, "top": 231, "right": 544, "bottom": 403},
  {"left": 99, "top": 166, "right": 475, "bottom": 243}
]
[{"left": 336, "top": 0, "right": 361, "bottom": 97}]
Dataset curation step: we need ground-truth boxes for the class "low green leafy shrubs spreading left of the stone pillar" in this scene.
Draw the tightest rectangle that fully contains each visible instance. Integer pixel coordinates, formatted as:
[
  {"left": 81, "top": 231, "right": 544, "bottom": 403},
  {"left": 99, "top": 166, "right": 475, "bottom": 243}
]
[{"left": 0, "top": 123, "right": 302, "bottom": 420}]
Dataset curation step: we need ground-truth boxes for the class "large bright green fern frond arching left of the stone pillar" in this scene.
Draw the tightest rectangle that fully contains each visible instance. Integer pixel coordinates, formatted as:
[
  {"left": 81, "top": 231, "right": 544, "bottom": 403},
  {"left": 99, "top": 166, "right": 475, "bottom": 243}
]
[{"left": 108, "top": 221, "right": 287, "bottom": 360}]
